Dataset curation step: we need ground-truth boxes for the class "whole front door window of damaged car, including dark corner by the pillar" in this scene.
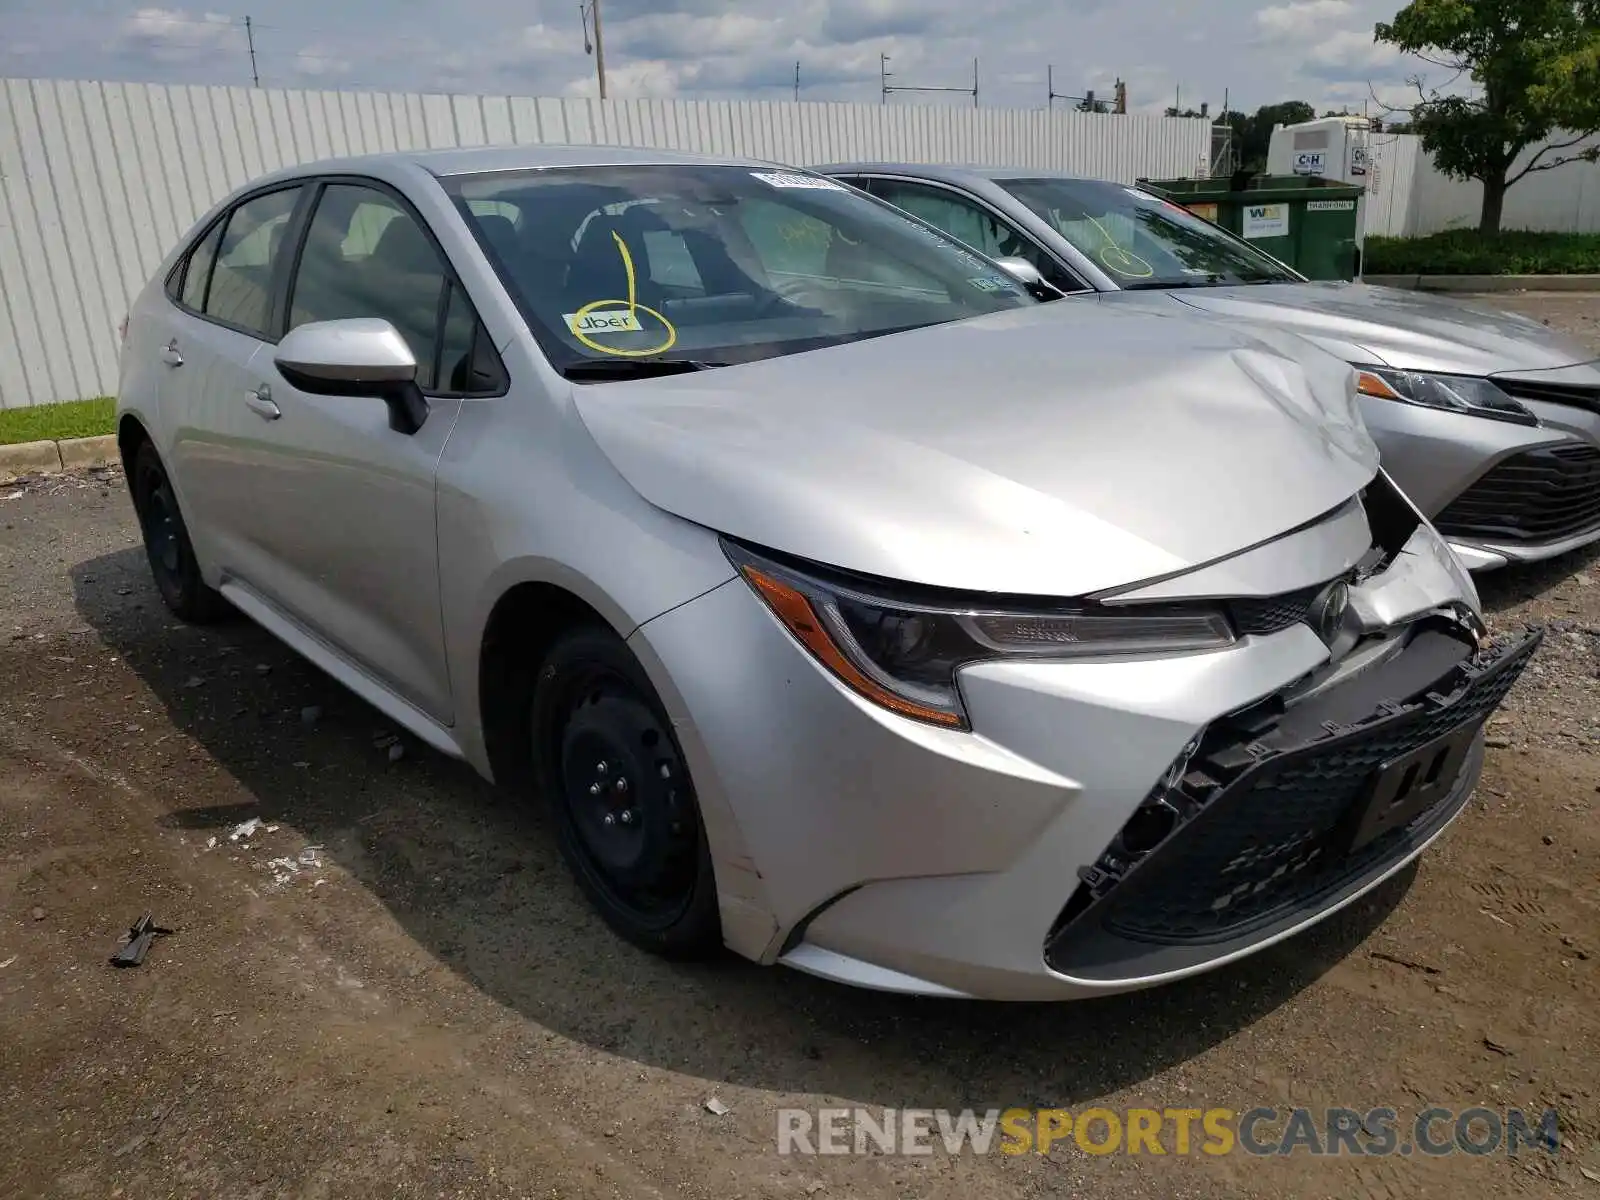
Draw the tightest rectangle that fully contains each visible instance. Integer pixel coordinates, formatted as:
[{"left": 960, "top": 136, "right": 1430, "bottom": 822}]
[{"left": 288, "top": 184, "right": 502, "bottom": 394}]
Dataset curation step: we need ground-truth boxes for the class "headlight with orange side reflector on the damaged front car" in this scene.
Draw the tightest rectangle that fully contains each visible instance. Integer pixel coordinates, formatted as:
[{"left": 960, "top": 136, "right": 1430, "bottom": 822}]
[{"left": 723, "top": 541, "right": 1234, "bottom": 730}]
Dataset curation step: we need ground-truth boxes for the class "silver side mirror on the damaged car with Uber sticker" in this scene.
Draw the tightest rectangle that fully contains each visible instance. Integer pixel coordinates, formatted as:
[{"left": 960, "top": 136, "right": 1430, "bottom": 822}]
[{"left": 272, "top": 317, "right": 427, "bottom": 434}]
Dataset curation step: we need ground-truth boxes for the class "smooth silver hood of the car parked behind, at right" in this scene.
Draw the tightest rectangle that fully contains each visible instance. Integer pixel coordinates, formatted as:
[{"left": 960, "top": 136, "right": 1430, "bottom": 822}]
[{"left": 1170, "top": 283, "right": 1594, "bottom": 374}]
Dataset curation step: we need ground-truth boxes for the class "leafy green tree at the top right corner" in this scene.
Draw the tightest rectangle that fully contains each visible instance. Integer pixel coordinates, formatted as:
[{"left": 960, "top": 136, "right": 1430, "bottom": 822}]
[{"left": 1374, "top": 0, "right": 1600, "bottom": 234}]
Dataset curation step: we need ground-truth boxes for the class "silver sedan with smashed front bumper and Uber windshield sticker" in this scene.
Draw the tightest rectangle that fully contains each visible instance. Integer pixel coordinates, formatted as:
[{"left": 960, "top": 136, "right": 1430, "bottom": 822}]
[{"left": 118, "top": 147, "right": 1538, "bottom": 998}]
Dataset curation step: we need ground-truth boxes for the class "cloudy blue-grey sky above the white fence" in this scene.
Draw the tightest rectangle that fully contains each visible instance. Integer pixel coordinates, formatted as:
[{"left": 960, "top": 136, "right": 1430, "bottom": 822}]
[{"left": 0, "top": 0, "right": 1445, "bottom": 112}]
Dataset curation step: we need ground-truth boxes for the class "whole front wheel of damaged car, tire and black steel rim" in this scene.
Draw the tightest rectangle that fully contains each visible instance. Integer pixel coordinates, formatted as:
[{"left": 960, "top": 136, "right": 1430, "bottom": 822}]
[{"left": 531, "top": 627, "right": 722, "bottom": 958}]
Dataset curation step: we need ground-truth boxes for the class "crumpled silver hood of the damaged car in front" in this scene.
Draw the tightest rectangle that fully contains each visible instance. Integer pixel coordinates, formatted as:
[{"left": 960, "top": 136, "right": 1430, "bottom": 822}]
[{"left": 573, "top": 304, "right": 1378, "bottom": 595}]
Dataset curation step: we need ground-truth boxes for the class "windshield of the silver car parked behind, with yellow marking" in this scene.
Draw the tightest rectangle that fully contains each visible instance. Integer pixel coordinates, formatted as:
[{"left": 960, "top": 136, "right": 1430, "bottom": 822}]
[{"left": 997, "top": 179, "right": 1298, "bottom": 288}]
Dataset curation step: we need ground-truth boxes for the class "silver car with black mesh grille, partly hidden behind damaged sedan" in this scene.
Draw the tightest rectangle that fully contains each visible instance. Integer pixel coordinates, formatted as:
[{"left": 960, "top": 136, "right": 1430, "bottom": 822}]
[{"left": 818, "top": 163, "right": 1600, "bottom": 570}]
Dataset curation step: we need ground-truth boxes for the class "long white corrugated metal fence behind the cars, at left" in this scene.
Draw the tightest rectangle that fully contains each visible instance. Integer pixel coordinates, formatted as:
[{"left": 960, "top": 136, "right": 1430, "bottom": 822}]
[{"left": 0, "top": 80, "right": 1210, "bottom": 408}]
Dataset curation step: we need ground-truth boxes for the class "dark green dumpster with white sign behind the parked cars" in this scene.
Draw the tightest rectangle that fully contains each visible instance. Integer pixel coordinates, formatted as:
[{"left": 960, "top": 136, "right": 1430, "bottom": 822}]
[{"left": 1139, "top": 174, "right": 1365, "bottom": 278}]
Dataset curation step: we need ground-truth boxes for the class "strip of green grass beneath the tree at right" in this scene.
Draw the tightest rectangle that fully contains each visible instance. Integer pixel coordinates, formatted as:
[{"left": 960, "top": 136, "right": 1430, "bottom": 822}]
[{"left": 1362, "top": 229, "right": 1600, "bottom": 275}]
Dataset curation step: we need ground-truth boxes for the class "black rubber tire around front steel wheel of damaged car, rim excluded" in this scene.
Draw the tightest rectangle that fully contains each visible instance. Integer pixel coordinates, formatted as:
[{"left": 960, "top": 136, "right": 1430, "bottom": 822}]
[{"left": 528, "top": 627, "right": 722, "bottom": 958}]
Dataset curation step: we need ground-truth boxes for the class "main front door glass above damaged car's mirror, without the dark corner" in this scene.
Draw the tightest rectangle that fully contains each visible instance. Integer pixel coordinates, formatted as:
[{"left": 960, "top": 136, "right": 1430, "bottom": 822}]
[{"left": 290, "top": 184, "right": 450, "bottom": 390}]
